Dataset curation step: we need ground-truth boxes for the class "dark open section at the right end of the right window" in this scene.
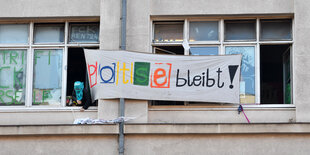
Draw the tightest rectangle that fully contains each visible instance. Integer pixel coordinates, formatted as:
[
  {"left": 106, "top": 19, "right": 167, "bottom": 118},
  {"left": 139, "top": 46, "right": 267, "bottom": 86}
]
[{"left": 260, "top": 45, "right": 290, "bottom": 104}]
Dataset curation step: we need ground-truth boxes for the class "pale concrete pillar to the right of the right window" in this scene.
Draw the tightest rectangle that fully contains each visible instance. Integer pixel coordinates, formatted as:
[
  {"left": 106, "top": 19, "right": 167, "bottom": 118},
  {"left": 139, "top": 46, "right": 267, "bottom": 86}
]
[{"left": 293, "top": 0, "right": 310, "bottom": 122}]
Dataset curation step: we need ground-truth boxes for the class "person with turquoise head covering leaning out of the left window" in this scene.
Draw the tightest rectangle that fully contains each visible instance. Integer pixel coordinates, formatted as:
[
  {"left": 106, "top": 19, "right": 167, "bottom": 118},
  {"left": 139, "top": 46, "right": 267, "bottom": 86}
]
[{"left": 72, "top": 81, "right": 91, "bottom": 111}]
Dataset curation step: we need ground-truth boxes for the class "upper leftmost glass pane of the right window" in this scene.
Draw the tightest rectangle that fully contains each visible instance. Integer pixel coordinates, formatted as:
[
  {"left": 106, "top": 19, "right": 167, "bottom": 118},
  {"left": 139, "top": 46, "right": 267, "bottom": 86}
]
[{"left": 154, "top": 23, "right": 183, "bottom": 42}]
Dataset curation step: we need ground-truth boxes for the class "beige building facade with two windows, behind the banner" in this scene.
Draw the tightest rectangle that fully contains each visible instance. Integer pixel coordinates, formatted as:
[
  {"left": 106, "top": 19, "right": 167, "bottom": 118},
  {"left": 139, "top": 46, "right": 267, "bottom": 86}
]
[{"left": 0, "top": 0, "right": 310, "bottom": 154}]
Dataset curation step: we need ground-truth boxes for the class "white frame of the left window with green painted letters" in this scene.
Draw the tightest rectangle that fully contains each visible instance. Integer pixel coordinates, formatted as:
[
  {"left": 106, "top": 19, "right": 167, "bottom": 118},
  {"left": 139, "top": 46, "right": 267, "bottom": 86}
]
[{"left": 0, "top": 19, "right": 100, "bottom": 111}]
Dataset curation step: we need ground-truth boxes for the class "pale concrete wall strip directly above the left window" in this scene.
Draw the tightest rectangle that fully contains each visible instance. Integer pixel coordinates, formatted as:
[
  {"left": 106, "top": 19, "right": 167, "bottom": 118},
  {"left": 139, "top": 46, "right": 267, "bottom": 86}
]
[{"left": 0, "top": 0, "right": 100, "bottom": 18}]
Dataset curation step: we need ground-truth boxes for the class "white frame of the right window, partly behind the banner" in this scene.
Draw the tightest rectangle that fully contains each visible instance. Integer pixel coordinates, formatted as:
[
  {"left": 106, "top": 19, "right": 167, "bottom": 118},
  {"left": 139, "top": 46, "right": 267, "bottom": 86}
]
[{"left": 150, "top": 15, "right": 295, "bottom": 108}]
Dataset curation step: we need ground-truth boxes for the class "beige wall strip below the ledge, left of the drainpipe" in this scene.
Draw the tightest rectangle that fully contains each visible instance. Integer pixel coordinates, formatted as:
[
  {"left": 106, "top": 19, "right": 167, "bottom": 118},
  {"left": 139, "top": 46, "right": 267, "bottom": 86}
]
[{"left": 0, "top": 135, "right": 118, "bottom": 155}]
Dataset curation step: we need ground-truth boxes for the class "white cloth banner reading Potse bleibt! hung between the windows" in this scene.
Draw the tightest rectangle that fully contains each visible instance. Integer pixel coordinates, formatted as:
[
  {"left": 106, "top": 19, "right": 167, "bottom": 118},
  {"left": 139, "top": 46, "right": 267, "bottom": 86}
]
[{"left": 85, "top": 50, "right": 241, "bottom": 104}]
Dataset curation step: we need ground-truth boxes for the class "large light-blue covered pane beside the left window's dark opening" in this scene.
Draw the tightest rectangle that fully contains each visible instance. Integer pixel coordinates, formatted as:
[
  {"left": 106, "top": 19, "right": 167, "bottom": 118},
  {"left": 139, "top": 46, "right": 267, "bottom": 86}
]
[{"left": 32, "top": 49, "right": 63, "bottom": 105}]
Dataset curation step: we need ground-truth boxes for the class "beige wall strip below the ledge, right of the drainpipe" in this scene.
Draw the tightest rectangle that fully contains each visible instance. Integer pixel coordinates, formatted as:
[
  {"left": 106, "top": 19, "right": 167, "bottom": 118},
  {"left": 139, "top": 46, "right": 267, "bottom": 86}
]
[{"left": 125, "top": 134, "right": 310, "bottom": 155}]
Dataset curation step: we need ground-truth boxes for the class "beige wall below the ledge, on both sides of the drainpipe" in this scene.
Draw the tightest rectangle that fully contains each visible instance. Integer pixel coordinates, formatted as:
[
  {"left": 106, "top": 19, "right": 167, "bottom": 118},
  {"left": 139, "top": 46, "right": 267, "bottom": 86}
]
[{"left": 0, "top": 134, "right": 310, "bottom": 155}]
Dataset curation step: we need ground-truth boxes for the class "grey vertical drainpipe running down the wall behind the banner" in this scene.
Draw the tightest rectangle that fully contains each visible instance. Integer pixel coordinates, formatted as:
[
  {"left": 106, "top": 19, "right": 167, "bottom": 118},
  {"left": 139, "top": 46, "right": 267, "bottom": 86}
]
[{"left": 118, "top": 0, "right": 127, "bottom": 155}]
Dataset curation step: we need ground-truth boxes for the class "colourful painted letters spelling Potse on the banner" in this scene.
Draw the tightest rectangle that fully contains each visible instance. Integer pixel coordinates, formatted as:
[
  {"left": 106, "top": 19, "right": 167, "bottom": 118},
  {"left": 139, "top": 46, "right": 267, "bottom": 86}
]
[{"left": 87, "top": 62, "right": 172, "bottom": 88}]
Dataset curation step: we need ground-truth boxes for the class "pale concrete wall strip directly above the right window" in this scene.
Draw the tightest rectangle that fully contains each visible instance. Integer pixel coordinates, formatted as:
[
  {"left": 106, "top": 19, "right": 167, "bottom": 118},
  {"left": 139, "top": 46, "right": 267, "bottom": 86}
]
[{"left": 151, "top": 0, "right": 294, "bottom": 16}]
